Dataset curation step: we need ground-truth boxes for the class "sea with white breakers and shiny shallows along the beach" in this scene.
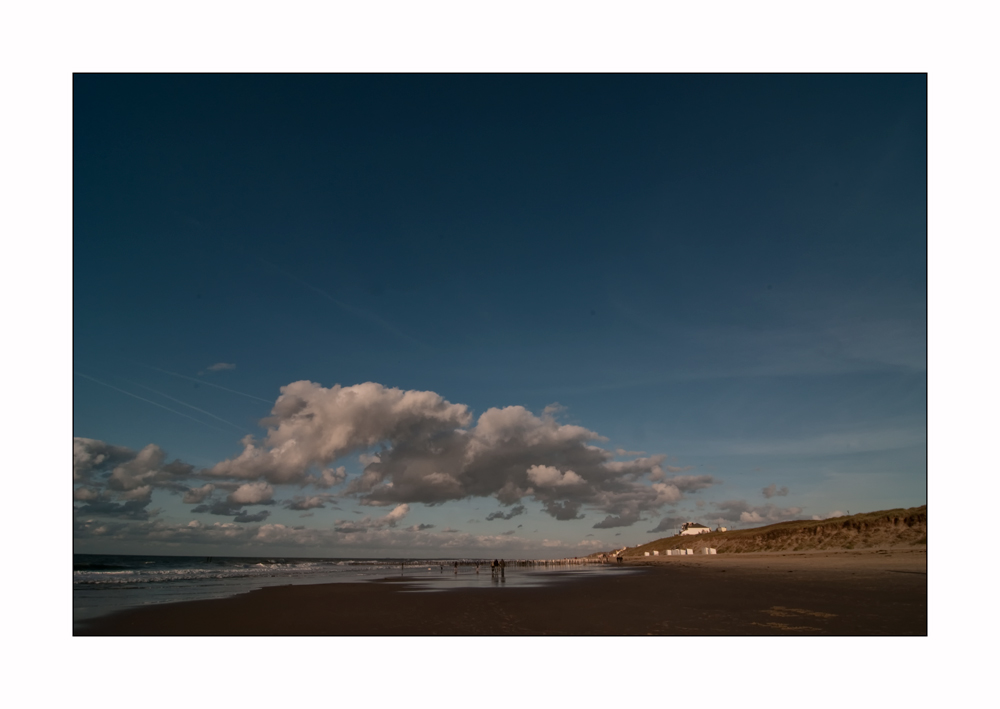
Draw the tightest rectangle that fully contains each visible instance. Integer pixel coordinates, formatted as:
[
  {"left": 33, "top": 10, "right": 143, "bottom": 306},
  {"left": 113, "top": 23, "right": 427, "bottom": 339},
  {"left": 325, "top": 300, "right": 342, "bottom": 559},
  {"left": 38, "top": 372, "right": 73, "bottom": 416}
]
[{"left": 73, "top": 554, "right": 621, "bottom": 624}]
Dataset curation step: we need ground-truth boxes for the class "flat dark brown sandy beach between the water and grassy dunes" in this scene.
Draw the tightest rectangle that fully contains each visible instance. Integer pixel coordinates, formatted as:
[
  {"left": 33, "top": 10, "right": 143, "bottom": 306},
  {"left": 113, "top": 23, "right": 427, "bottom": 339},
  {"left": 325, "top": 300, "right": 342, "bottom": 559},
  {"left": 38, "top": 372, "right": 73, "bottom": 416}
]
[{"left": 74, "top": 548, "right": 927, "bottom": 636}]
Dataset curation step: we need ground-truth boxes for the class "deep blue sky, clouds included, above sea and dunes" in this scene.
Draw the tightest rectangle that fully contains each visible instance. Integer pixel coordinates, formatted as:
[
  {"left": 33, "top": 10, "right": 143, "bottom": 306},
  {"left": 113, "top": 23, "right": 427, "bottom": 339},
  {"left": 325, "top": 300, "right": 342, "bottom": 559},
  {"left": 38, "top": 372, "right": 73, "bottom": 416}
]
[{"left": 72, "top": 74, "right": 928, "bottom": 558}]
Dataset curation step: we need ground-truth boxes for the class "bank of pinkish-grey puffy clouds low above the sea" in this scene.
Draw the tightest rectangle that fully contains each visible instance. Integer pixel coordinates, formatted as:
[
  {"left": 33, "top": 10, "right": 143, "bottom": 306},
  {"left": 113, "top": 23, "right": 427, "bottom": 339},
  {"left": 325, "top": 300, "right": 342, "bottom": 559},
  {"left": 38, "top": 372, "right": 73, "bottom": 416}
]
[{"left": 74, "top": 381, "right": 801, "bottom": 542}]
